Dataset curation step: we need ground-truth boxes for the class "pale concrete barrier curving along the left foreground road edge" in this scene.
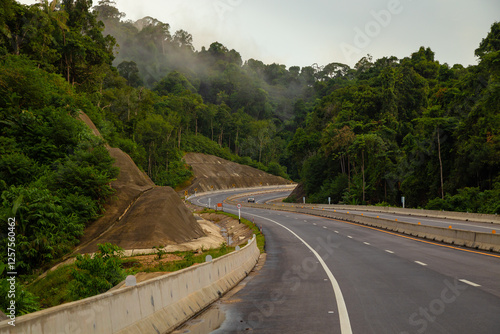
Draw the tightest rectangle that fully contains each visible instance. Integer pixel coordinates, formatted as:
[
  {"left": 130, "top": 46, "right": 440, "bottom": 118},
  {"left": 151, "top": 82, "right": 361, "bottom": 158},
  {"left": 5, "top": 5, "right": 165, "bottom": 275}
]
[{"left": 0, "top": 236, "right": 260, "bottom": 334}]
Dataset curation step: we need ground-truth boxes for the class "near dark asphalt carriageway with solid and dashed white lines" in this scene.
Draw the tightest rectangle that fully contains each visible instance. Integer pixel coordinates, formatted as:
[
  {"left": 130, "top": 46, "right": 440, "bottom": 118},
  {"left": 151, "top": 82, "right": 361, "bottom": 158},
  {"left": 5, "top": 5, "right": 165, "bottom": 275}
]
[{"left": 187, "top": 189, "right": 500, "bottom": 334}]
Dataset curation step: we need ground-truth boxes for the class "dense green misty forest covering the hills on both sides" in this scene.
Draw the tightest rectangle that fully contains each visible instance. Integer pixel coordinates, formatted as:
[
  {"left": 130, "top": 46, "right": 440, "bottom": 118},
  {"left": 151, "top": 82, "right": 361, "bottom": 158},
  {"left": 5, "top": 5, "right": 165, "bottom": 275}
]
[{"left": 0, "top": 0, "right": 500, "bottom": 282}]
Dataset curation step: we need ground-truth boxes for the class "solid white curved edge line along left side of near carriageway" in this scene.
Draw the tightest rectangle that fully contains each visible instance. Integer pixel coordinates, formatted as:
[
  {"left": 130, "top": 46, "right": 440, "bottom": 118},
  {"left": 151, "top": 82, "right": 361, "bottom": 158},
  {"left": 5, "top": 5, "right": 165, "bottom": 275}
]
[{"left": 248, "top": 213, "right": 352, "bottom": 334}]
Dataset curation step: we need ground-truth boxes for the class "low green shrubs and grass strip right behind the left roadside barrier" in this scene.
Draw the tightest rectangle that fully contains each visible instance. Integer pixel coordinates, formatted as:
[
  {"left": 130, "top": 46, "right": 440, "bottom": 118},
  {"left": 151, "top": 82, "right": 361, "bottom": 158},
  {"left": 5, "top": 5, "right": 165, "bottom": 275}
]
[{"left": 25, "top": 243, "right": 238, "bottom": 314}]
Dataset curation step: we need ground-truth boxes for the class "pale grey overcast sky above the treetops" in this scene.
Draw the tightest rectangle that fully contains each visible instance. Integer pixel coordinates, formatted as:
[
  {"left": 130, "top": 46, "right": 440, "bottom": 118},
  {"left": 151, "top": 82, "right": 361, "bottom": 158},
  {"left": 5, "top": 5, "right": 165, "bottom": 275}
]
[{"left": 20, "top": 0, "right": 500, "bottom": 67}]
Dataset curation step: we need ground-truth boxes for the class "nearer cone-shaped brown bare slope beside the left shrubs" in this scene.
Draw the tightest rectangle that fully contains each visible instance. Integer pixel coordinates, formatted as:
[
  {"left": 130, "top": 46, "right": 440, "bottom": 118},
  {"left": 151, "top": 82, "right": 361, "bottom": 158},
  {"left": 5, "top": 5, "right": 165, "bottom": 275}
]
[{"left": 76, "top": 113, "right": 204, "bottom": 253}]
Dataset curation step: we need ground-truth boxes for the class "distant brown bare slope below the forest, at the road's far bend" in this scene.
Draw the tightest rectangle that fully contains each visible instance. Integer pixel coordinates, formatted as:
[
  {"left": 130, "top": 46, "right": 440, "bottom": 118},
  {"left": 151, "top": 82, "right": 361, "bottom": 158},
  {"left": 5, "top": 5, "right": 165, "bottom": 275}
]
[{"left": 184, "top": 153, "right": 290, "bottom": 193}]
